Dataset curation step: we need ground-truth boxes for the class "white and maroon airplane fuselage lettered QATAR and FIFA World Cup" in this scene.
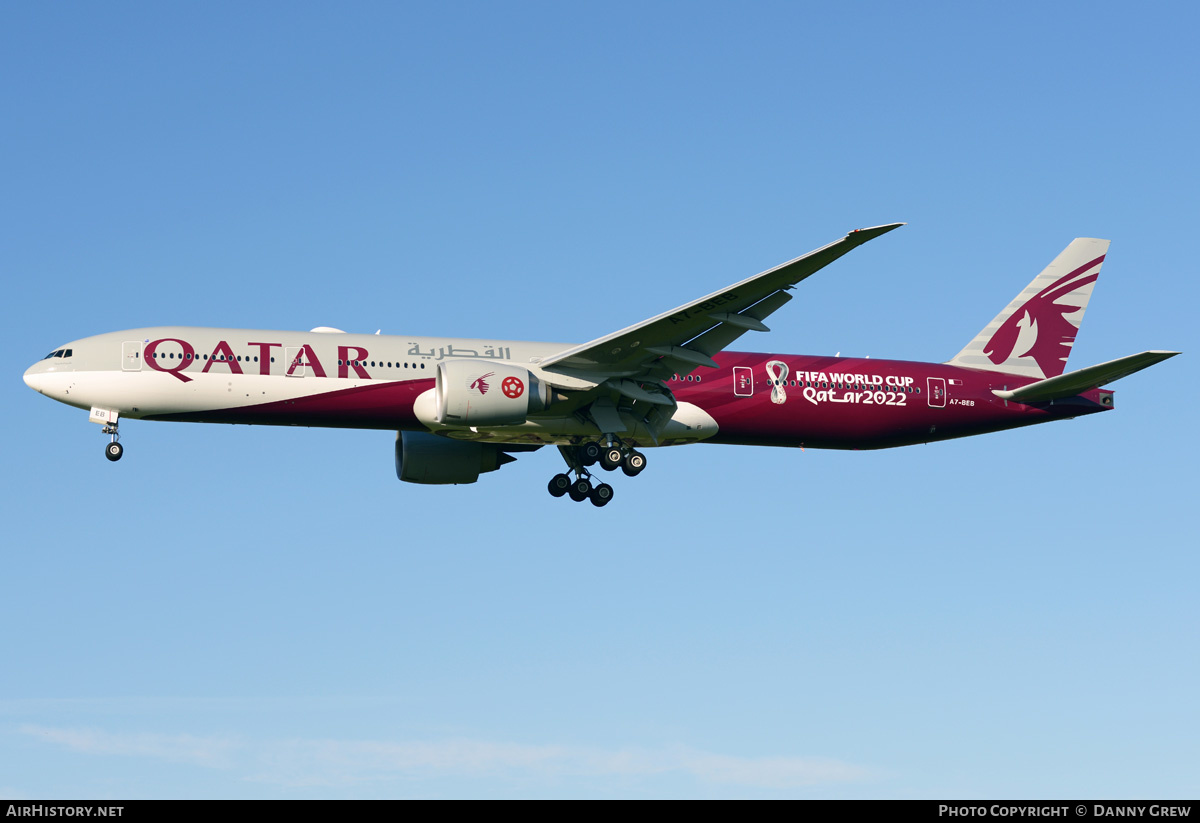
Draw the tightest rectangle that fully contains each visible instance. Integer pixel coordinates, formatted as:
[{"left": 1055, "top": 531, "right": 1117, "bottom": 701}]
[{"left": 25, "top": 326, "right": 1112, "bottom": 449}]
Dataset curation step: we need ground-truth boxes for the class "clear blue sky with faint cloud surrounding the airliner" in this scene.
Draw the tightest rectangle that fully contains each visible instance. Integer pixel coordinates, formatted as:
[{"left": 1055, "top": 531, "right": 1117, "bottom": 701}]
[{"left": 0, "top": 2, "right": 1200, "bottom": 798}]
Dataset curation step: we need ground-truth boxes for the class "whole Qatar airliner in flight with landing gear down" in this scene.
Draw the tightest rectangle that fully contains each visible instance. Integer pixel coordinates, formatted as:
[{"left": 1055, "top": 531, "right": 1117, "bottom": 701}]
[{"left": 25, "top": 223, "right": 1178, "bottom": 506}]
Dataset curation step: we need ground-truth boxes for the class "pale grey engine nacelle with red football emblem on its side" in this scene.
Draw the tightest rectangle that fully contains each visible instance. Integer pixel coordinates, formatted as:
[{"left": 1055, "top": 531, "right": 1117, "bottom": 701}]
[{"left": 433, "top": 360, "right": 550, "bottom": 427}]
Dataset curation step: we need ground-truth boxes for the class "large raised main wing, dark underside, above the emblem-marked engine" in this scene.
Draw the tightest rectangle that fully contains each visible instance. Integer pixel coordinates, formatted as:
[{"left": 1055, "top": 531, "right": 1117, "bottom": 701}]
[{"left": 539, "top": 223, "right": 904, "bottom": 406}]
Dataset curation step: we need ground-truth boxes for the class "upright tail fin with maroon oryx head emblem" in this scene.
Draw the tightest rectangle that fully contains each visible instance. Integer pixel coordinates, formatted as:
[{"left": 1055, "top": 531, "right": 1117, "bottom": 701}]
[{"left": 947, "top": 238, "right": 1109, "bottom": 379}]
